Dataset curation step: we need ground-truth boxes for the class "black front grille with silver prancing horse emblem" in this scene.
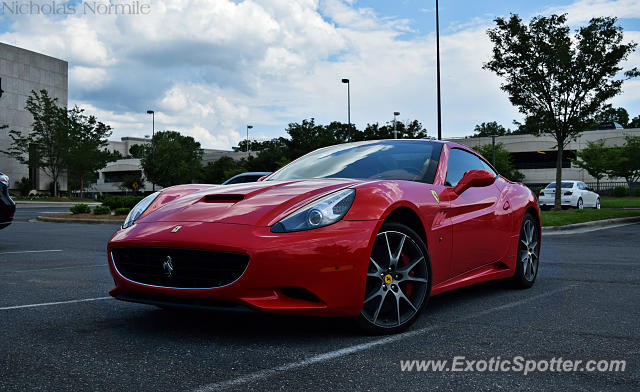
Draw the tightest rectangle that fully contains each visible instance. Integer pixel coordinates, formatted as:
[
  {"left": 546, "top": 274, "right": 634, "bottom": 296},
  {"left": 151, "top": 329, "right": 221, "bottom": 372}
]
[{"left": 111, "top": 247, "right": 249, "bottom": 288}]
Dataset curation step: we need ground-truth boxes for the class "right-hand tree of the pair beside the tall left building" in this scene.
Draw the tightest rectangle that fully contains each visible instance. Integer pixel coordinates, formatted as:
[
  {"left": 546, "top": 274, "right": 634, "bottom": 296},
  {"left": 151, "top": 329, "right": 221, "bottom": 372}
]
[{"left": 65, "top": 106, "right": 116, "bottom": 197}]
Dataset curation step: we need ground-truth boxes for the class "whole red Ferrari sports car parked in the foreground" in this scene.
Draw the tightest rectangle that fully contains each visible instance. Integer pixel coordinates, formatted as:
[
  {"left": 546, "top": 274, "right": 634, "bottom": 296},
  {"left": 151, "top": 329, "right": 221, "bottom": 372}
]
[{"left": 108, "top": 140, "right": 540, "bottom": 333}]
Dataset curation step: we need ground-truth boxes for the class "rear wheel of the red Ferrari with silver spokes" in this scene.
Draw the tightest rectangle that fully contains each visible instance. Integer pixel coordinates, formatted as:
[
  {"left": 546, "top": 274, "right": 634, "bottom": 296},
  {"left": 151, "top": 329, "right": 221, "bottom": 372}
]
[{"left": 511, "top": 212, "right": 540, "bottom": 289}]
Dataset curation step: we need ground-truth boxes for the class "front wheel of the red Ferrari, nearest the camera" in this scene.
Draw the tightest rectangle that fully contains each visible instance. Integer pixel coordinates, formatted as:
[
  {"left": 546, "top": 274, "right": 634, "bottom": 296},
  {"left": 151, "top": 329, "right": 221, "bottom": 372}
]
[{"left": 356, "top": 222, "right": 431, "bottom": 335}]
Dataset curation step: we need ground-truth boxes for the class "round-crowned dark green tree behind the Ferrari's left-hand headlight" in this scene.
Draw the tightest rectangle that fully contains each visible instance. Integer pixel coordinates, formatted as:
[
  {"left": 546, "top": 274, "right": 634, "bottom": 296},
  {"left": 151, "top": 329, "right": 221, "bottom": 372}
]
[{"left": 140, "top": 131, "right": 202, "bottom": 187}]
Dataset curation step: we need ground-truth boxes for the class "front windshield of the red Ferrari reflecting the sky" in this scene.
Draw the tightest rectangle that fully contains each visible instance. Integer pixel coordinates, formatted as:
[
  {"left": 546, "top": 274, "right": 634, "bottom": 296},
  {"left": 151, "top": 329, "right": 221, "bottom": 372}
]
[{"left": 267, "top": 140, "right": 442, "bottom": 183}]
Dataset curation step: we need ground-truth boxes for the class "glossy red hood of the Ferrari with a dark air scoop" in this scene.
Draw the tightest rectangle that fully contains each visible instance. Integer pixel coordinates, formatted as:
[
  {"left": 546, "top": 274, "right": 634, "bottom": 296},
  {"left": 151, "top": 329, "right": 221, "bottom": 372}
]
[{"left": 138, "top": 179, "right": 365, "bottom": 226}]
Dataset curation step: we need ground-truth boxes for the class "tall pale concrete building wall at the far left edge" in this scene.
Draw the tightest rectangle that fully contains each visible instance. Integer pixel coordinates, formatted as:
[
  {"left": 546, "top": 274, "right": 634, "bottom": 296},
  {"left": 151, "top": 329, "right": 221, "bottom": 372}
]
[{"left": 0, "top": 42, "right": 68, "bottom": 190}]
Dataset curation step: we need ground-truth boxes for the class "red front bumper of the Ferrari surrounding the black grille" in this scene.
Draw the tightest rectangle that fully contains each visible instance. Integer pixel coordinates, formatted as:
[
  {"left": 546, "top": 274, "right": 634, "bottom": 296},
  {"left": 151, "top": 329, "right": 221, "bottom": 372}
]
[{"left": 108, "top": 221, "right": 381, "bottom": 316}]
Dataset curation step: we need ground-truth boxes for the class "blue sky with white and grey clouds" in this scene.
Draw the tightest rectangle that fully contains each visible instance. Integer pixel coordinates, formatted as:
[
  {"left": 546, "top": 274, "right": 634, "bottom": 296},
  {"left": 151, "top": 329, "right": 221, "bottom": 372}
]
[{"left": 0, "top": 0, "right": 640, "bottom": 149}]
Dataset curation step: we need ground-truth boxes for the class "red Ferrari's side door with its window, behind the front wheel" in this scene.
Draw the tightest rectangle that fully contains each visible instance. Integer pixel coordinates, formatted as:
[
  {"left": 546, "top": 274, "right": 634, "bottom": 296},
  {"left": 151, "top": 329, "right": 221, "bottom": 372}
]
[{"left": 445, "top": 148, "right": 507, "bottom": 277}]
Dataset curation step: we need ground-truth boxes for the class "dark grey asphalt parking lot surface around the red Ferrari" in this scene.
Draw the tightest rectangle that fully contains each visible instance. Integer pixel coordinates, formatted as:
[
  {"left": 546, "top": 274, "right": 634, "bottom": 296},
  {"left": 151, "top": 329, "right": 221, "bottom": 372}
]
[{"left": 0, "top": 207, "right": 640, "bottom": 391}]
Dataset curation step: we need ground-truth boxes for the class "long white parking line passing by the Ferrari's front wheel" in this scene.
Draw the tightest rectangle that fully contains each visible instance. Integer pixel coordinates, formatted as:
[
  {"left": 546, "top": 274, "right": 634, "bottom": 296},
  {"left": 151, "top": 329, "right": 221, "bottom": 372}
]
[{"left": 194, "top": 285, "right": 576, "bottom": 392}]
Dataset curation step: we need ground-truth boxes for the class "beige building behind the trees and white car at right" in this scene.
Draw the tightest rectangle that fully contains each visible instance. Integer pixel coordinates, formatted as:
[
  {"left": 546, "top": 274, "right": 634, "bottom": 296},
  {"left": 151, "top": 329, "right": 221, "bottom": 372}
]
[{"left": 448, "top": 128, "right": 640, "bottom": 184}]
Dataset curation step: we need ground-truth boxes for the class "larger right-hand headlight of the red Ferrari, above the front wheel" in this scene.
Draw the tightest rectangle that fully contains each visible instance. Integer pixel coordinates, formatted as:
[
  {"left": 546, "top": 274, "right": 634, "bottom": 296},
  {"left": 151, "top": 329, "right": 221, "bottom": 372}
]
[{"left": 271, "top": 189, "right": 356, "bottom": 233}]
